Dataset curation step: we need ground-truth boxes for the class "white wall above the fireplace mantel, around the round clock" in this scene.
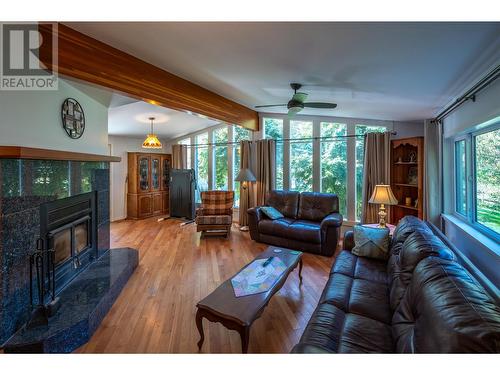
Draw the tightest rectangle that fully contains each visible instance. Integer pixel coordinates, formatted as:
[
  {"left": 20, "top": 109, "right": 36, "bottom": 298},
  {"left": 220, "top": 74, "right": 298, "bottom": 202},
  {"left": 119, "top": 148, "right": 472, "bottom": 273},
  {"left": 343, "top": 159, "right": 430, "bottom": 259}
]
[{"left": 0, "top": 79, "right": 108, "bottom": 155}]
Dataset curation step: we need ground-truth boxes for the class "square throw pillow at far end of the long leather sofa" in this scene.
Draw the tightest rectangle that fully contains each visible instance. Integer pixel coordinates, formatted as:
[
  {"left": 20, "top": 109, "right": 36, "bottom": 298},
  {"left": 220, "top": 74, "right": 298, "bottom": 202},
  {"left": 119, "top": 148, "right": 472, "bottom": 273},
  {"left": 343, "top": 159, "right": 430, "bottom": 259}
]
[{"left": 352, "top": 225, "right": 389, "bottom": 260}]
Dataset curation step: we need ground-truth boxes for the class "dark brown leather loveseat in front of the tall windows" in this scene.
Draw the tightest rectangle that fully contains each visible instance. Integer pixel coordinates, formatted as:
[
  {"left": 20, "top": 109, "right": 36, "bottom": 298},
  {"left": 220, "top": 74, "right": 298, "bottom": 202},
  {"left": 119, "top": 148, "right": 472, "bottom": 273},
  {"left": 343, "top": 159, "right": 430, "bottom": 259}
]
[{"left": 248, "top": 190, "right": 342, "bottom": 256}]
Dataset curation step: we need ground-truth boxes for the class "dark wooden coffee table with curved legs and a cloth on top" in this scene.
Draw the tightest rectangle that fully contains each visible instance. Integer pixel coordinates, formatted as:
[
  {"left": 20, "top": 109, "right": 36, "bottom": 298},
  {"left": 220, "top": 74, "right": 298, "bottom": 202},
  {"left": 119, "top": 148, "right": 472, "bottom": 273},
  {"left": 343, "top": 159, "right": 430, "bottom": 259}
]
[{"left": 196, "top": 246, "right": 302, "bottom": 353}]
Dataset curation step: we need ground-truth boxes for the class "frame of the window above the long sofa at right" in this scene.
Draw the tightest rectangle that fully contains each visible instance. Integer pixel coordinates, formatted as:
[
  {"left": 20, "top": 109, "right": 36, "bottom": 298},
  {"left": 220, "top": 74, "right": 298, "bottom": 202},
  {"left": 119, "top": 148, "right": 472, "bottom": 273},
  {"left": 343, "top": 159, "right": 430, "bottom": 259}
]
[{"left": 452, "top": 121, "right": 500, "bottom": 241}]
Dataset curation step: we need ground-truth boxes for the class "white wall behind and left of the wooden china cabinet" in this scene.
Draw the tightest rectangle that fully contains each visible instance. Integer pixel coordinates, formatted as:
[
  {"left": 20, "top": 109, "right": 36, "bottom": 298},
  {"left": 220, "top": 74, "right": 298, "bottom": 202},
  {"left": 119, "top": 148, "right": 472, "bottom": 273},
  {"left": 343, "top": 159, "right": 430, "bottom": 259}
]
[{"left": 108, "top": 135, "right": 171, "bottom": 221}]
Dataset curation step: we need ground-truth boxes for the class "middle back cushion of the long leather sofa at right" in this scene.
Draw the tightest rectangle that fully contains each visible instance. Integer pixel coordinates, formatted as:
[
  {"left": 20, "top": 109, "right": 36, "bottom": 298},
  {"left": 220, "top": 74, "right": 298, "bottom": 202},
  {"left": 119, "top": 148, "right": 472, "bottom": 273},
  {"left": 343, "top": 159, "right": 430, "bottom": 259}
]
[{"left": 387, "top": 228, "right": 456, "bottom": 310}]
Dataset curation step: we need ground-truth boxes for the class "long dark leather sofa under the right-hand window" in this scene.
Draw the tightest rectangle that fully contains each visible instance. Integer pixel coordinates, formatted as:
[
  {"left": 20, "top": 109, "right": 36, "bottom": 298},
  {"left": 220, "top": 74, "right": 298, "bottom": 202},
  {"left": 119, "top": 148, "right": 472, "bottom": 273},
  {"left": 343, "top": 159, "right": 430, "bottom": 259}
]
[{"left": 292, "top": 216, "right": 500, "bottom": 353}]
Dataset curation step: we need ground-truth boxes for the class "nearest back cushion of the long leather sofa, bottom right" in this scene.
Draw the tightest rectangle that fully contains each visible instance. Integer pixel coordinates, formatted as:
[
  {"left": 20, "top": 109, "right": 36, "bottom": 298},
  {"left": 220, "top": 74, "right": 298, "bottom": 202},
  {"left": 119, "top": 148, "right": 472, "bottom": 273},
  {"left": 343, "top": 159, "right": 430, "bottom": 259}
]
[{"left": 392, "top": 256, "right": 500, "bottom": 353}]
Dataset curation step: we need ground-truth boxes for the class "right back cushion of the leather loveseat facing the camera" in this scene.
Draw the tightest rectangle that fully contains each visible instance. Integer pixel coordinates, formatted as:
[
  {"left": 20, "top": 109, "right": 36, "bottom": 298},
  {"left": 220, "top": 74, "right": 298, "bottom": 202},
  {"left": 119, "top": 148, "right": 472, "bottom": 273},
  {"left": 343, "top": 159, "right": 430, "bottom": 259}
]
[{"left": 298, "top": 193, "right": 339, "bottom": 221}]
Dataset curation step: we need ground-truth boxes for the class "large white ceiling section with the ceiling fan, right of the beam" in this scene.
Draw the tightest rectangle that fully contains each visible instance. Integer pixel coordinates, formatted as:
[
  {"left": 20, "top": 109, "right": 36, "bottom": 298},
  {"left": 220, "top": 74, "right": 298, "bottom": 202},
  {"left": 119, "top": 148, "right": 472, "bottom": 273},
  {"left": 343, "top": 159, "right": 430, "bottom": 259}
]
[{"left": 68, "top": 22, "right": 500, "bottom": 121}]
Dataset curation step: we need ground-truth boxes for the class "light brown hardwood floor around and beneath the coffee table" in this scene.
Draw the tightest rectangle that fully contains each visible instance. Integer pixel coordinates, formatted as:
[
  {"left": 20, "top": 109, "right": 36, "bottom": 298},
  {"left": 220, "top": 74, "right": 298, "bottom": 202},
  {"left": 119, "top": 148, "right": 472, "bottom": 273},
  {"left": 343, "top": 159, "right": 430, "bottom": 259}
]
[{"left": 76, "top": 218, "right": 333, "bottom": 353}]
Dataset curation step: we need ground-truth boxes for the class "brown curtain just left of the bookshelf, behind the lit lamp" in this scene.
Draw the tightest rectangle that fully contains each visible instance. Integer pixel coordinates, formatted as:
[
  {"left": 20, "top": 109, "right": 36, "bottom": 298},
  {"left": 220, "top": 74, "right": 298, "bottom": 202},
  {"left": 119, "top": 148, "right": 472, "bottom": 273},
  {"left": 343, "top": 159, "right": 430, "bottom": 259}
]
[{"left": 361, "top": 132, "right": 391, "bottom": 223}]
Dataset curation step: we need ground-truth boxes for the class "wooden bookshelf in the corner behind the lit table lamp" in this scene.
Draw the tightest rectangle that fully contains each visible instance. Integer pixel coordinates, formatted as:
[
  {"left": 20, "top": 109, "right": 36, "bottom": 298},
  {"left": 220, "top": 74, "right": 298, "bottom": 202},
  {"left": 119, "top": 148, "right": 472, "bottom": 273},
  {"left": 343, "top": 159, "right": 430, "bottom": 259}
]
[{"left": 389, "top": 137, "right": 424, "bottom": 224}]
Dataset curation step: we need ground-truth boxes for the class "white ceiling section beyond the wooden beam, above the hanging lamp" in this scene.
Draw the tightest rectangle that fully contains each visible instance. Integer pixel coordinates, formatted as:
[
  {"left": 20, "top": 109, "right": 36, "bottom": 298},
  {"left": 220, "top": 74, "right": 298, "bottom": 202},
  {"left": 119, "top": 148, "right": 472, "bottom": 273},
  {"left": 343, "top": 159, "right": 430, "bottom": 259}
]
[{"left": 108, "top": 100, "right": 217, "bottom": 139}]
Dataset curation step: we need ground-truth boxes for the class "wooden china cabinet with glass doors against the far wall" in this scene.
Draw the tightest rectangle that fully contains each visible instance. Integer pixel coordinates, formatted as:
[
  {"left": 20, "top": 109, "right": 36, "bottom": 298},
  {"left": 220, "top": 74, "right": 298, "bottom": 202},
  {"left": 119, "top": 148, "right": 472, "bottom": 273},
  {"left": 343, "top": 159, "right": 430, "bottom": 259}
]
[{"left": 127, "top": 152, "right": 172, "bottom": 219}]
